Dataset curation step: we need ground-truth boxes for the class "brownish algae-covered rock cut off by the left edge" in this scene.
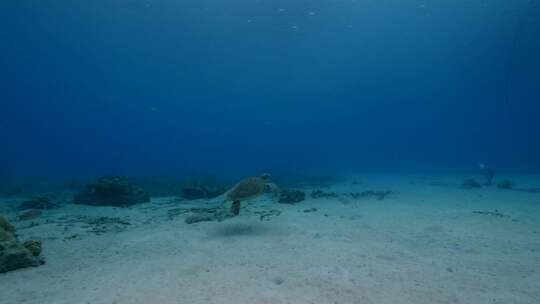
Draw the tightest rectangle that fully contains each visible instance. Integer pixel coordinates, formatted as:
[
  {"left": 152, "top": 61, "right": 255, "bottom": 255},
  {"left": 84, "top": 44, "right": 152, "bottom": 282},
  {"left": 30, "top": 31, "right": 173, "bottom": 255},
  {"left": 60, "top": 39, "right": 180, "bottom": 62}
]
[{"left": 0, "top": 216, "right": 44, "bottom": 273}]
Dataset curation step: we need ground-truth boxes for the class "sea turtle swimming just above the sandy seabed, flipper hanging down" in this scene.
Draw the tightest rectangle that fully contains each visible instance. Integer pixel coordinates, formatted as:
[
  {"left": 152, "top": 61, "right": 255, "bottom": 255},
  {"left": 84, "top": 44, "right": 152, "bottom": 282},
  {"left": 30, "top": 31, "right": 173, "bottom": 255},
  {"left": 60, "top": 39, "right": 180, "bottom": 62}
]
[{"left": 225, "top": 174, "right": 270, "bottom": 216}]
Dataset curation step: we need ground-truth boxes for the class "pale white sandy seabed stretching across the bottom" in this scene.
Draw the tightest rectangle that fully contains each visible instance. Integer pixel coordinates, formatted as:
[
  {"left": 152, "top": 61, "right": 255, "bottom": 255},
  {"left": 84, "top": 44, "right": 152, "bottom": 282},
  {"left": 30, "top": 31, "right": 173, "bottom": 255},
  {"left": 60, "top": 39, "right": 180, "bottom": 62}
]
[{"left": 0, "top": 175, "right": 540, "bottom": 304}]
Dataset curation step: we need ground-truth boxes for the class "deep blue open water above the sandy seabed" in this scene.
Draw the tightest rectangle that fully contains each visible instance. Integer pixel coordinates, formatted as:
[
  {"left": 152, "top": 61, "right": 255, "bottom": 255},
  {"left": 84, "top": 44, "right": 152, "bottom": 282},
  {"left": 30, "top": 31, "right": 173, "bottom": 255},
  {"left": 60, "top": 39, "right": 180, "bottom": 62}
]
[{"left": 0, "top": 0, "right": 540, "bottom": 177}]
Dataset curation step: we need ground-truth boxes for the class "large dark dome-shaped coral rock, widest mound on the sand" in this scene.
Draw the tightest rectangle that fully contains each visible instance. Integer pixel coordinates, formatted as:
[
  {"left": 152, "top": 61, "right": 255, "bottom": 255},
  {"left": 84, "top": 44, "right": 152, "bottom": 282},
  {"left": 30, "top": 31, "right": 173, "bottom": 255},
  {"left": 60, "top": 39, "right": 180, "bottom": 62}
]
[{"left": 73, "top": 176, "right": 150, "bottom": 207}]
